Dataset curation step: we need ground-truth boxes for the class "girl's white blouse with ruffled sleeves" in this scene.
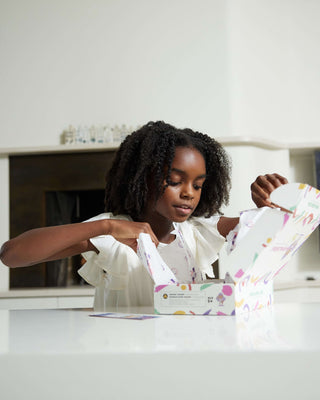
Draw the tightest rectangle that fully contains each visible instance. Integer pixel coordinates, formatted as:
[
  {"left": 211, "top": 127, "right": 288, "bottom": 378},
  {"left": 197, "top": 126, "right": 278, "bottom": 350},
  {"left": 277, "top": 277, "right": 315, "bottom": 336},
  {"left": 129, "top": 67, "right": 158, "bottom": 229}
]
[{"left": 78, "top": 213, "right": 225, "bottom": 311}]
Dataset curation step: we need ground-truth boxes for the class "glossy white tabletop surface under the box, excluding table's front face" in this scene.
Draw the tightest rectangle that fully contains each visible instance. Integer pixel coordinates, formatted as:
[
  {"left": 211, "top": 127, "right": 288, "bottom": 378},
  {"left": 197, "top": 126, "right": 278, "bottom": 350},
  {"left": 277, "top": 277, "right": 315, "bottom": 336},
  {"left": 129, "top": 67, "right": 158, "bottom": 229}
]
[{"left": 0, "top": 303, "right": 320, "bottom": 354}]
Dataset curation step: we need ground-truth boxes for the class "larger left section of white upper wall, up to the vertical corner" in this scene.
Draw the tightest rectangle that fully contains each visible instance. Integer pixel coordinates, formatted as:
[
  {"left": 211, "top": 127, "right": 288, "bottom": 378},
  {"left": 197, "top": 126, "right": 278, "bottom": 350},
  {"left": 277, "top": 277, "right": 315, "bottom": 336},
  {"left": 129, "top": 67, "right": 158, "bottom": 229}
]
[{"left": 0, "top": 0, "right": 229, "bottom": 147}]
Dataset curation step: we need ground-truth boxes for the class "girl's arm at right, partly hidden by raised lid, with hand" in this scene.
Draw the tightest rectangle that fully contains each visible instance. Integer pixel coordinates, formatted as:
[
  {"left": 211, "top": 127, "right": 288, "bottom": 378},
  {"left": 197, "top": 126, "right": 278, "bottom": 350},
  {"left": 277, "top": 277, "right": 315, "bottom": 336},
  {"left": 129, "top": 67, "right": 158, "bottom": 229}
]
[{"left": 218, "top": 174, "right": 288, "bottom": 237}]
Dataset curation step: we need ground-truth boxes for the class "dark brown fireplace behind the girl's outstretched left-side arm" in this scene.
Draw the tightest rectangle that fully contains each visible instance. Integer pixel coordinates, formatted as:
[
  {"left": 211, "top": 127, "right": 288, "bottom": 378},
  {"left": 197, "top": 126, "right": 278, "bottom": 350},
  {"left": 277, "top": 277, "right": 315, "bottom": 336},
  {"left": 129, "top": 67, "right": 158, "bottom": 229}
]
[{"left": 9, "top": 150, "right": 114, "bottom": 289}]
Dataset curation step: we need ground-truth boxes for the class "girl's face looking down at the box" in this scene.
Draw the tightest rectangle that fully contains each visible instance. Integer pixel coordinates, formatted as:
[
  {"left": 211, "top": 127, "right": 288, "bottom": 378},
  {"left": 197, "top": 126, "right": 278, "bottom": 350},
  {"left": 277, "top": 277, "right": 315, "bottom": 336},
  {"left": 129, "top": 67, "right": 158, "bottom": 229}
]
[{"left": 154, "top": 147, "right": 206, "bottom": 222}]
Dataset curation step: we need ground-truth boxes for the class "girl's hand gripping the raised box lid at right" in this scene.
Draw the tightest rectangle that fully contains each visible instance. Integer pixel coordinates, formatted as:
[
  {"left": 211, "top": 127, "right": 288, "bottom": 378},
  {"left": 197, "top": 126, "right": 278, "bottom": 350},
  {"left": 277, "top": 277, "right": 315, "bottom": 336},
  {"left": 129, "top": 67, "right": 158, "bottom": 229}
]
[{"left": 251, "top": 174, "right": 288, "bottom": 208}]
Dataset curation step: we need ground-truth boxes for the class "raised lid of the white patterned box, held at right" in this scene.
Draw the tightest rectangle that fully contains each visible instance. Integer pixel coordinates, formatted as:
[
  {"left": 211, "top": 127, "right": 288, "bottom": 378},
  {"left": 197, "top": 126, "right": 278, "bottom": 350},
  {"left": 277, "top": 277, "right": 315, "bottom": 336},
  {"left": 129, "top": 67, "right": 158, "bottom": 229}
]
[{"left": 225, "top": 183, "right": 320, "bottom": 283}]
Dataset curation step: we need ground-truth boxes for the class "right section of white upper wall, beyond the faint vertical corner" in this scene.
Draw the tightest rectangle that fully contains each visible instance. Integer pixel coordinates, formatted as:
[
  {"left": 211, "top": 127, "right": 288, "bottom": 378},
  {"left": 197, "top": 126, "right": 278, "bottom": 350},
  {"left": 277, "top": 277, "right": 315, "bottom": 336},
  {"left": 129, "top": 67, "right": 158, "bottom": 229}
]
[{"left": 227, "top": 0, "right": 320, "bottom": 142}]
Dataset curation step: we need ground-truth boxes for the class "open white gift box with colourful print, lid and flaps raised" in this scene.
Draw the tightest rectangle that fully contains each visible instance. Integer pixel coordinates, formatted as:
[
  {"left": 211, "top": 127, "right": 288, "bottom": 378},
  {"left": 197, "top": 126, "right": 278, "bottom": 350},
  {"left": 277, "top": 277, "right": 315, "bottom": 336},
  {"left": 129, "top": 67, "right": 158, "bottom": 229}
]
[{"left": 138, "top": 183, "right": 320, "bottom": 315}]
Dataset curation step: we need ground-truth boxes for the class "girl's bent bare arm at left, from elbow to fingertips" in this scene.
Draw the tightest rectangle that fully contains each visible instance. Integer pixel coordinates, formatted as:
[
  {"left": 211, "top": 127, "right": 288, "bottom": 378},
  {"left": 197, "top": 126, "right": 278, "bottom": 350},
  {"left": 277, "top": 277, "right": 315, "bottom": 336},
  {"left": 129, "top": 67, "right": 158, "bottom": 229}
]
[{"left": 0, "top": 219, "right": 158, "bottom": 268}]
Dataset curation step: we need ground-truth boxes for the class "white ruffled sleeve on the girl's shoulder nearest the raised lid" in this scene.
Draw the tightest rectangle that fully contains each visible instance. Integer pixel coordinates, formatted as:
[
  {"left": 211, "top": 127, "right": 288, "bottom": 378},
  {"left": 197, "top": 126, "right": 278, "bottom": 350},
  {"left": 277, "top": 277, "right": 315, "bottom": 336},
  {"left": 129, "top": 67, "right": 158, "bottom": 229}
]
[{"left": 179, "top": 216, "right": 225, "bottom": 278}]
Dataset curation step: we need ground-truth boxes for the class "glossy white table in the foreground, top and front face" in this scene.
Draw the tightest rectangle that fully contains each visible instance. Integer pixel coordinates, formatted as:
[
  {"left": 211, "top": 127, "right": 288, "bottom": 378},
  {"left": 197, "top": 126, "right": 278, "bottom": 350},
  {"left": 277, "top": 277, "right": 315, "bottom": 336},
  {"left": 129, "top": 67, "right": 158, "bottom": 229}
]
[{"left": 0, "top": 303, "right": 320, "bottom": 400}]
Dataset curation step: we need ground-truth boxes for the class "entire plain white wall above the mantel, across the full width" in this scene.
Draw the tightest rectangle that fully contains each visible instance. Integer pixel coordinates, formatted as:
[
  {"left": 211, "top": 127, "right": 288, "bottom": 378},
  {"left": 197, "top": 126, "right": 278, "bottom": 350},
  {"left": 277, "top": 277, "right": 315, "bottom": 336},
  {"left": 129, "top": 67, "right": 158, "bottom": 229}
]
[{"left": 0, "top": 0, "right": 320, "bottom": 147}]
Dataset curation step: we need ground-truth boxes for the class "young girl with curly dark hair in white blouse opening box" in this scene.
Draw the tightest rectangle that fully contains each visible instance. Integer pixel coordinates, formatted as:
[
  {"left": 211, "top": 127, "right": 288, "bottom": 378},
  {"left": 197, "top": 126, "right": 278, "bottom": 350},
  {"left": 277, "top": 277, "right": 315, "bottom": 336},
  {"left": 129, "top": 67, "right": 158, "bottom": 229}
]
[{"left": 1, "top": 121, "right": 287, "bottom": 311}]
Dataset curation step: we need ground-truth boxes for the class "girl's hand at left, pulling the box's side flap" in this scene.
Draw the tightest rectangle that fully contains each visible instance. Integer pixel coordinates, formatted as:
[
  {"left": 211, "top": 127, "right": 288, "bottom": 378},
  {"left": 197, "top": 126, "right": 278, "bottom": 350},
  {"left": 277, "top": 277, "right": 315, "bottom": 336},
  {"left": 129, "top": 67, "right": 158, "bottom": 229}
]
[{"left": 106, "top": 219, "right": 159, "bottom": 252}]
